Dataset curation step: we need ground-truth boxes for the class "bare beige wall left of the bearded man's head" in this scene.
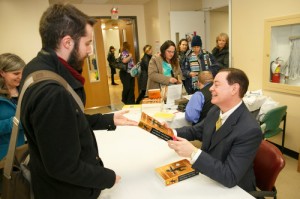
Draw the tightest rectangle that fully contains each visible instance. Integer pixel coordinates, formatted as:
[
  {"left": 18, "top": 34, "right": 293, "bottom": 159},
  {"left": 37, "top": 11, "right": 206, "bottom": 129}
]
[{"left": 0, "top": 0, "right": 49, "bottom": 63}]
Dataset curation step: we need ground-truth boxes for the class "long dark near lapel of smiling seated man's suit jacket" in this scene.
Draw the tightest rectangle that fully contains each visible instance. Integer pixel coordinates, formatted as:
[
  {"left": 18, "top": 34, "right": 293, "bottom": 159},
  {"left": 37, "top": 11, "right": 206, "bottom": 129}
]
[{"left": 209, "top": 103, "right": 246, "bottom": 150}]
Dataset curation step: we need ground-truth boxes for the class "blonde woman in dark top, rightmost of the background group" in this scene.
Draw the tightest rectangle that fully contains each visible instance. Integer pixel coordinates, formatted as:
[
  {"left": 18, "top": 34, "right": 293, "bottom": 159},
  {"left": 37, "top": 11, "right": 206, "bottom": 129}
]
[{"left": 212, "top": 33, "right": 229, "bottom": 68}]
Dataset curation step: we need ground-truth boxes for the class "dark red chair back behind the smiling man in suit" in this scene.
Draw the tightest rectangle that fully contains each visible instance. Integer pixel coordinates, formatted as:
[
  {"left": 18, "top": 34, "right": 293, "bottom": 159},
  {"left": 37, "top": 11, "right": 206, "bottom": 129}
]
[{"left": 253, "top": 140, "right": 285, "bottom": 191}]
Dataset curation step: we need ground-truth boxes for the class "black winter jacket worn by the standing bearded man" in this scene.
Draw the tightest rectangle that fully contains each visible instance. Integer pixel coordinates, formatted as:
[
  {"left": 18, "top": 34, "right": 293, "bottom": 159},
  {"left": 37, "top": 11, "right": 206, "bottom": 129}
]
[{"left": 21, "top": 50, "right": 116, "bottom": 199}]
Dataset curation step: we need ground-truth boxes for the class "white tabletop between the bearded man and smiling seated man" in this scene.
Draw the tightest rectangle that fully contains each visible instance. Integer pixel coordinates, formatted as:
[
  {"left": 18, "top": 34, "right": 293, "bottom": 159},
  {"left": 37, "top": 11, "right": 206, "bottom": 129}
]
[{"left": 95, "top": 126, "right": 253, "bottom": 199}]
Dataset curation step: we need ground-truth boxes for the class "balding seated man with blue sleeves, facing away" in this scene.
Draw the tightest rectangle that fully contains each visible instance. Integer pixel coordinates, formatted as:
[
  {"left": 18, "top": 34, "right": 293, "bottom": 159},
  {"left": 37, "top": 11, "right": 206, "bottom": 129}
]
[{"left": 185, "top": 71, "right": 214, "bottom": 125}]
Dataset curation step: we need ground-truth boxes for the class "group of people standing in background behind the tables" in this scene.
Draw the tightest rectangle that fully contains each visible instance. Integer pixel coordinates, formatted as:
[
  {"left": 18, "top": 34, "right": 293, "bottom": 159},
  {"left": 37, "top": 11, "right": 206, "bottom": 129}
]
[{"left": 107, "top": 33, "right": 229, "bottom": 104}]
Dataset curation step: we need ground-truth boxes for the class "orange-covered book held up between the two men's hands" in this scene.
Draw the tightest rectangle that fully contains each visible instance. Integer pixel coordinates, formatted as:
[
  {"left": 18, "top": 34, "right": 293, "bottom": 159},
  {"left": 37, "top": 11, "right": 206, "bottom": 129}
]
[{"left": 138, "top": 112, "right": 174, "bottom": 141}]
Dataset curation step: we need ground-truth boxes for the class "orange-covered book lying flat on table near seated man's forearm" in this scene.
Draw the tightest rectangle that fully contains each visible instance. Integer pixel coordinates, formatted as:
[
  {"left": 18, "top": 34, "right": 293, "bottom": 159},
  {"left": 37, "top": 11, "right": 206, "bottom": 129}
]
[{"left": 155, "top": 159, "right": 199, "bottom": 186}]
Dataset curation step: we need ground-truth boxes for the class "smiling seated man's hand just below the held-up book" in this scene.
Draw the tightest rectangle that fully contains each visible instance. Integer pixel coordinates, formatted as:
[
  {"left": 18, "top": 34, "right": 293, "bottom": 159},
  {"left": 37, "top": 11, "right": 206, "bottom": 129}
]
[{"left": 168, "top": 137, "right": 195, "bottom": 158}]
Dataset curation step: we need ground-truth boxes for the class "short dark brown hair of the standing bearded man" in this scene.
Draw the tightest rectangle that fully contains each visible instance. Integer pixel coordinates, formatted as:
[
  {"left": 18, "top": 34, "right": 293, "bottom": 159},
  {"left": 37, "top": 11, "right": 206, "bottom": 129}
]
[{"left": 39, "top": 4, "right": 96, "bottom": 50}]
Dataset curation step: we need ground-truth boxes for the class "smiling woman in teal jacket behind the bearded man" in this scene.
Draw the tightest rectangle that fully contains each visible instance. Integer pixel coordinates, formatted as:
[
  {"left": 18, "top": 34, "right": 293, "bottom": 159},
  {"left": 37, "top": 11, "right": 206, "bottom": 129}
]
[{"left": 0, "top": 53, "right": 25, "bottom": 191}]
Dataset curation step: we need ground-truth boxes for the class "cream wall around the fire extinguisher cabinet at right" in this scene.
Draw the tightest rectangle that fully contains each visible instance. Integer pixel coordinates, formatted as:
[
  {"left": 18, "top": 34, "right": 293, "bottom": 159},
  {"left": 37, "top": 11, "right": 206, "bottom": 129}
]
[{"left": 232, "top": 0, "right": 300, "bottom": 152}]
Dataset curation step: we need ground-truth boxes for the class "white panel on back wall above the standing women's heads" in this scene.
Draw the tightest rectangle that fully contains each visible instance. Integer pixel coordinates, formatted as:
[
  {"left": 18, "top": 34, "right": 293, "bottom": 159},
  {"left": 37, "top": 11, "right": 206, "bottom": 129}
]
[{"left": 170, "top": 11, "right": 205, "bottom": 48}]
